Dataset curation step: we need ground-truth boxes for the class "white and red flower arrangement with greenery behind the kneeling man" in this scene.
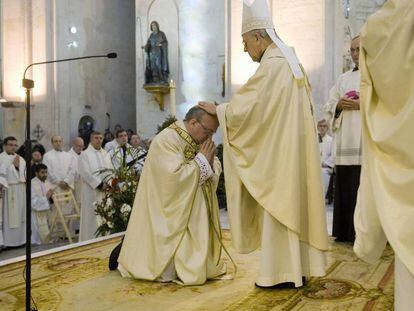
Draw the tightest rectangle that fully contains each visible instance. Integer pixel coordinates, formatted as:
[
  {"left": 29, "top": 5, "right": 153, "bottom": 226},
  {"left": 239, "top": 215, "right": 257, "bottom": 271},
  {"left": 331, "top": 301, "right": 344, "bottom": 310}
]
[{"left": 94, "top": 166, "right": 139, "bottom": 236}]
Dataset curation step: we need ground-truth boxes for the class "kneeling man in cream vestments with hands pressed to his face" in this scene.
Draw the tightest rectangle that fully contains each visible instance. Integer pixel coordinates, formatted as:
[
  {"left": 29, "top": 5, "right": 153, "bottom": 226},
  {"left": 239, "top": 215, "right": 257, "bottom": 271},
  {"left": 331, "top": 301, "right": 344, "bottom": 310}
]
[{"left": 118, "top": 107, "right": 225, "bottom": 285}]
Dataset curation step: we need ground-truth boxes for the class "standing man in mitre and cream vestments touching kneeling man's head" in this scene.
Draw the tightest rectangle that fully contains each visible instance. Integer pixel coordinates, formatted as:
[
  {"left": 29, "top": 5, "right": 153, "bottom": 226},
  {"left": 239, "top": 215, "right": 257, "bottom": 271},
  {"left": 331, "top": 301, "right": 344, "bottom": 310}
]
[{"left": 200, "top": 0, "right": 328, "bottom": 287}]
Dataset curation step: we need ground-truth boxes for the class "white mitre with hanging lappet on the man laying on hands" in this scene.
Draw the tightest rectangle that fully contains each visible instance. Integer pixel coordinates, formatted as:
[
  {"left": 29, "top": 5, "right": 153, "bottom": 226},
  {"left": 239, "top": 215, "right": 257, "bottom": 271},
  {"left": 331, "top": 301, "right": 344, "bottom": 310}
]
[{"left": 242, "top": 0, "right": 304, "bottom": 79}]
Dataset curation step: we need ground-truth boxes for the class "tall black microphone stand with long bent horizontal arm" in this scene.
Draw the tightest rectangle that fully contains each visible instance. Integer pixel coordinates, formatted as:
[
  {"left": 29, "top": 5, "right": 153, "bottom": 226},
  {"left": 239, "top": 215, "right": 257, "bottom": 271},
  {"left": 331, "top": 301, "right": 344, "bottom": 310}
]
[{"left": 22, "top": 53, "right": 117, "bottom": 311}]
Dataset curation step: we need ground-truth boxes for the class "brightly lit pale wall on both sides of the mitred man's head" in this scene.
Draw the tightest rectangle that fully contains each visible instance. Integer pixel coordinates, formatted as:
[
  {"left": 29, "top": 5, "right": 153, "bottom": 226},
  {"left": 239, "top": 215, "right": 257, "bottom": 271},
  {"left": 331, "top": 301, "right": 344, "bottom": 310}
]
[{"left": 228, "top": 0, "right": 342, "bottom": 118}]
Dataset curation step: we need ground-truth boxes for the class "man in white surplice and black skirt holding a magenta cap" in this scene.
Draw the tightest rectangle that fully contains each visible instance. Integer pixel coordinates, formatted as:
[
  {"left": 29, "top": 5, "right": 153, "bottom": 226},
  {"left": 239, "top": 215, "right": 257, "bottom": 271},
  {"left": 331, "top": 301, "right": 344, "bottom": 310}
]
[{"left": 325, "top": 37, "right": 362, "bottom": 242}]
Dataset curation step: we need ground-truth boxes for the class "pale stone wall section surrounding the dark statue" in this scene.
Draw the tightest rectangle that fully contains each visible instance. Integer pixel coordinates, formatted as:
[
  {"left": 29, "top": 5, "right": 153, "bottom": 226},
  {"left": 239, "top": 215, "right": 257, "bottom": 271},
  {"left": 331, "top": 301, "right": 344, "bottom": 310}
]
[{"left": 135, "top": 0, "right": 226, "bottom": 137}]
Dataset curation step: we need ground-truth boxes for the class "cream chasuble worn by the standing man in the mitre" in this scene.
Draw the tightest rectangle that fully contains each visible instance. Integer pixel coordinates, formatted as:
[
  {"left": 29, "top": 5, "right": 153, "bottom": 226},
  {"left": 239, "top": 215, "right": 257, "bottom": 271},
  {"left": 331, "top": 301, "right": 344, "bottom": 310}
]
[{"left": 217, "top": 44, "right": 328, "bottom": 253}]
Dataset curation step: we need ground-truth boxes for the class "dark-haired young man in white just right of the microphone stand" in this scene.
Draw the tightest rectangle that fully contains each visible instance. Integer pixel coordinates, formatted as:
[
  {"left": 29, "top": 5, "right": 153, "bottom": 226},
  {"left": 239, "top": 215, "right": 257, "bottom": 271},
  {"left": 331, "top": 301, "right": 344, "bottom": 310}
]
[{"left": 32, "top": 163, "right": 54, "bottom": 244}]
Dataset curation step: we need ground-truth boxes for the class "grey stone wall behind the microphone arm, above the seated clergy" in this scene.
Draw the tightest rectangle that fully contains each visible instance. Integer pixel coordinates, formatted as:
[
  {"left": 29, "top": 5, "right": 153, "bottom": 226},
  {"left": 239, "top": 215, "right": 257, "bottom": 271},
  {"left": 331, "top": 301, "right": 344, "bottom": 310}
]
[{"left": 1, "top": 0, "right": 135, "bottom": 151}]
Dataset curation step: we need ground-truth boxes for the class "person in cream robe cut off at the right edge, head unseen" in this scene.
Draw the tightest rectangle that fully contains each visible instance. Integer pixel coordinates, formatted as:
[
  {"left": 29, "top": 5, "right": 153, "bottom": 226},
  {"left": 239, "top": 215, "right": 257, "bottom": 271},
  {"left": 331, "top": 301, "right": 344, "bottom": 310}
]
[{"left": 354, "top": 0, "right": 414, "bottom": 311}]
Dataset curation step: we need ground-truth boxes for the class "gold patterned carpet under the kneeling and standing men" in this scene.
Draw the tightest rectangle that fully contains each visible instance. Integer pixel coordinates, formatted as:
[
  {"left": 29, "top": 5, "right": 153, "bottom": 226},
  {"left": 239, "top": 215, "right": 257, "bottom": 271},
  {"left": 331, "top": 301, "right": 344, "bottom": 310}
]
[{"left": 0, "top": 230, "right": 394, "bottom": 311}]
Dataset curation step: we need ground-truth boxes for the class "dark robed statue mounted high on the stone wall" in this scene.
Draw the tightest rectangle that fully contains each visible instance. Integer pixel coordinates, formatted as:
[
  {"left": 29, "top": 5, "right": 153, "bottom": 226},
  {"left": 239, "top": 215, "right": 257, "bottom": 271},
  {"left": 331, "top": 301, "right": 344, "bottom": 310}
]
[{"left": 143, "top": 21, "right": 170, "bottom": 84}]
